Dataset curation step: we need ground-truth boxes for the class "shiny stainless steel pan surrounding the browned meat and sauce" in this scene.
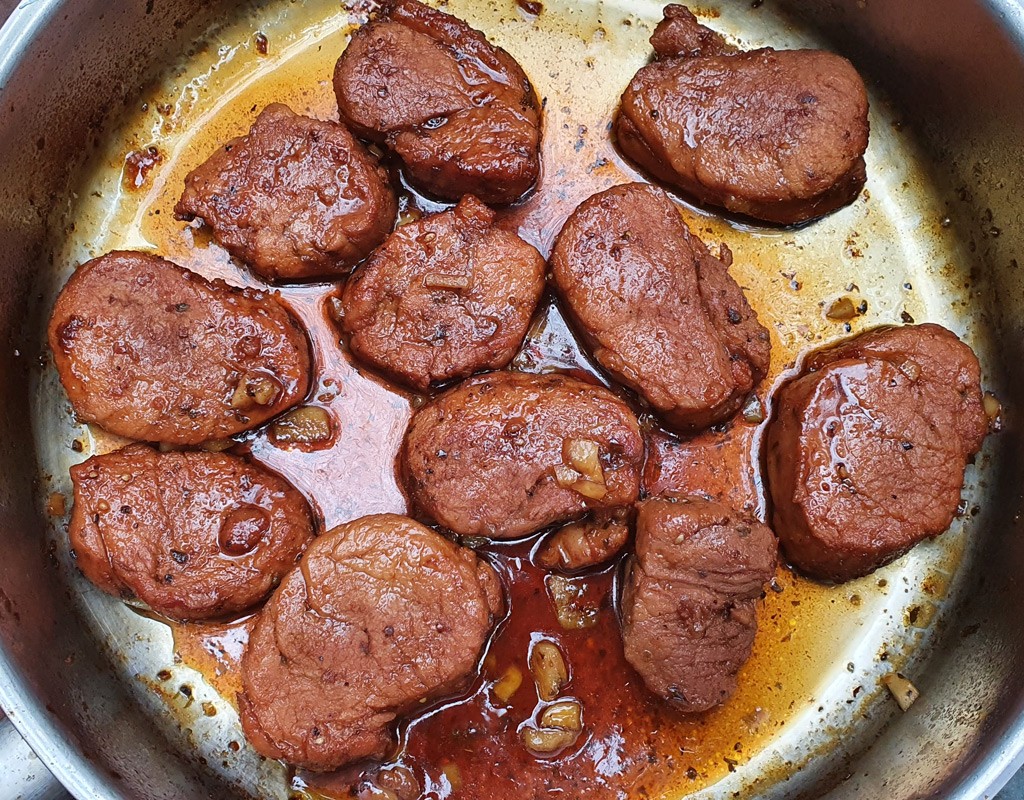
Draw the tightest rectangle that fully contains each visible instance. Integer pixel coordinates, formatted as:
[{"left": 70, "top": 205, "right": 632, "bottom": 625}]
[{"left": 0, "top": 0, "right": 1024, "bottom": 800}]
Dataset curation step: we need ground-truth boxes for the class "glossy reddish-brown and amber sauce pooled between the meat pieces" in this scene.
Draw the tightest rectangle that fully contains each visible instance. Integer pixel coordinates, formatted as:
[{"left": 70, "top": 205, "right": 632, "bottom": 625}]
[{"left": 61, "top": 3, "right": 966, "bottom": 800}]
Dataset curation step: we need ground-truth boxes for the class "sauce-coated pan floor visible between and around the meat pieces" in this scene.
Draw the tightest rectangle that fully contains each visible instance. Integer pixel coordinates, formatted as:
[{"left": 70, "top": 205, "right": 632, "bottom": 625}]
[{"left": 46, "top": 0, "right": 983, "bottom": 800}]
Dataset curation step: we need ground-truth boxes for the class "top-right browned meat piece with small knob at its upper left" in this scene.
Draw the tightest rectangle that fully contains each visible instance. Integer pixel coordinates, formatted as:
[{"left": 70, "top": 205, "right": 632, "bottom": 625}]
[{"left": 614, "top": 5, "right": 868, "bottom": 224}]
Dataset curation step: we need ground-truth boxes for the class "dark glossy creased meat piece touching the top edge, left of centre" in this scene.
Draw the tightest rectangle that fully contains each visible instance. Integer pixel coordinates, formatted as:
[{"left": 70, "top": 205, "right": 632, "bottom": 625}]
[{"left": 334, "top": 0, "right": 541, "bottom": 204}]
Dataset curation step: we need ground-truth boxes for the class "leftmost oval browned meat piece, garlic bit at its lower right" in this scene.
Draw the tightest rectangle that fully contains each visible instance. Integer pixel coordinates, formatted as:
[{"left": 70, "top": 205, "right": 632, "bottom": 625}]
[{"left": 49, "top": 251, "right": 310, "bottom": 445}]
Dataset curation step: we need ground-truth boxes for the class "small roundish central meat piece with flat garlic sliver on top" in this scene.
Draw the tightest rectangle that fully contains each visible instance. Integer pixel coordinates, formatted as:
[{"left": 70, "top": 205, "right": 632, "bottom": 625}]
[{"left": 341, "top": 197, "right": 546, "bottom": 391}]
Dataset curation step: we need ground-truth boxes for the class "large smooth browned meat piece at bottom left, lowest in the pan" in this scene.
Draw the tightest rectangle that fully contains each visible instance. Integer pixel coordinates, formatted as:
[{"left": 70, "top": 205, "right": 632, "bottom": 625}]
[{"left": 239, "top": 514, "right": 504, "bottom": 770}]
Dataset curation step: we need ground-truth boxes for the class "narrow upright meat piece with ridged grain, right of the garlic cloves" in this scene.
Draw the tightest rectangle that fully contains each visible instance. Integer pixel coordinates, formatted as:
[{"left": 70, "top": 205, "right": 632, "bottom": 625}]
[{"left": 623, "top": 495, "right": 776, "bottom": 712}]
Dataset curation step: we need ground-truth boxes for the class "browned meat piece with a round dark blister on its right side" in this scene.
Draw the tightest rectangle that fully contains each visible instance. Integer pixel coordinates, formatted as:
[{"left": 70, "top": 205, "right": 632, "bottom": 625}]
[{"left": 68, "top": 445, "right": 313, "bottom": 620}]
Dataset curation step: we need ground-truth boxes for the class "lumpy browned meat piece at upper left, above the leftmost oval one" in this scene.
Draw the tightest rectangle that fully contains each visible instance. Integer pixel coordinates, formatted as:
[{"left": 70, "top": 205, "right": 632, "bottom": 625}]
[{"left": 174, "top": 103, "right": 398, "bottom": 281}]
